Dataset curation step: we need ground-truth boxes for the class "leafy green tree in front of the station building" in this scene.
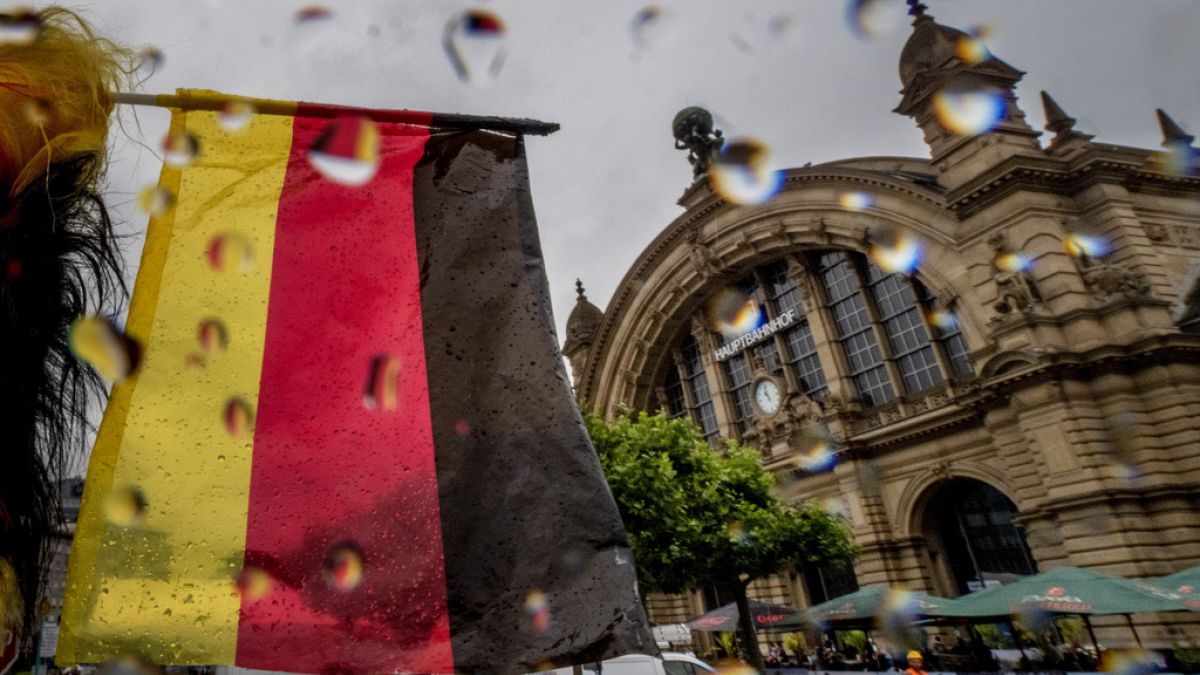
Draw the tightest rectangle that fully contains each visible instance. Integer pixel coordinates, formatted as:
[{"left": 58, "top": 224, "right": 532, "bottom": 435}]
[{"left": 584, "top": 413, "right": 856, "bottom": 671}]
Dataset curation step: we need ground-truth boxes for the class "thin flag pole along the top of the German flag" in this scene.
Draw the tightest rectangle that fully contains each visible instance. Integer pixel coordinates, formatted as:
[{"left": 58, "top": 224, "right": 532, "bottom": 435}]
[{"left": 113, "top": 91, "right": 559, "bottom": 136}]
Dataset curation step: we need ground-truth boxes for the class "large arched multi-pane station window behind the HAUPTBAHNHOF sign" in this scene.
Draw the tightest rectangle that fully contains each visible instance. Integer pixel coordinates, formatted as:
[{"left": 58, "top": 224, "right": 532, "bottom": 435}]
[{"left": 659, "top": 250, "right": 972, "bottom": 442}]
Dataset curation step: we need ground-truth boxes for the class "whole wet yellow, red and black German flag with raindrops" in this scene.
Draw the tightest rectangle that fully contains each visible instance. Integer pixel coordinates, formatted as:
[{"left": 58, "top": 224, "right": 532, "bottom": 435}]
[{"left": 58, "top": 92, "right": 654, "bottom": 673}]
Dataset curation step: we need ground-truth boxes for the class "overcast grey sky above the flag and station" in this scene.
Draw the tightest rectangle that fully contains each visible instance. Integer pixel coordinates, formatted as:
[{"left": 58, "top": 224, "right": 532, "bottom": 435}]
[{"left": 84, "top": 0, "right": 1200, "bottom": 353}]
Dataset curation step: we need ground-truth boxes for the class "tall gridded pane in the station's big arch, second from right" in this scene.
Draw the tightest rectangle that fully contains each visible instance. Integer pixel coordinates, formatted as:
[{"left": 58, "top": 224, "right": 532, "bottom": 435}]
[{"left": 866, "top": 263, "right": 943, "bottom": 394}]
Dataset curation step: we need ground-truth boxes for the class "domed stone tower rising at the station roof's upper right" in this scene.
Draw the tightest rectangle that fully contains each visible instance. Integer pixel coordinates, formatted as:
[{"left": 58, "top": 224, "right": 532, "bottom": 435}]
[{"left": 895, "top": 0, "right": 1039, "bottom": 187}]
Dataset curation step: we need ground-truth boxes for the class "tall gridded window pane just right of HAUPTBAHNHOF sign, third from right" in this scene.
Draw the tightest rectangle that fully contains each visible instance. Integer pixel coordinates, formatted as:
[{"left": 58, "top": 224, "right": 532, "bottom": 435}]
[{"left": 818, "top": 251, "right": 895, "bottom": 407}]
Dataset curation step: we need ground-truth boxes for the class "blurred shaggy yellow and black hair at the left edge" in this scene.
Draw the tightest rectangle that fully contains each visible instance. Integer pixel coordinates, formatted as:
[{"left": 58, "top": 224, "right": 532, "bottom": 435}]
[{"left": 0, "top": 7, "right": 132, "bottom": 631}]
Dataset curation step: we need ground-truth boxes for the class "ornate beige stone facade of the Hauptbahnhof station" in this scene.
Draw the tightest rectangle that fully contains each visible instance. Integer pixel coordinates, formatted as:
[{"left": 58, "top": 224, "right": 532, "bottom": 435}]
[{"left": 566, "top": 6, "right": 1200, "bottom": 646}]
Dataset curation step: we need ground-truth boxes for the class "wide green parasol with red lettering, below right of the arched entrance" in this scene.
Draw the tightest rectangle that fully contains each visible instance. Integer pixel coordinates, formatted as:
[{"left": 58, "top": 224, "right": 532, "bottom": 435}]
[{"left": 941, "top": 567, "right": 1189, "bottom": 617}]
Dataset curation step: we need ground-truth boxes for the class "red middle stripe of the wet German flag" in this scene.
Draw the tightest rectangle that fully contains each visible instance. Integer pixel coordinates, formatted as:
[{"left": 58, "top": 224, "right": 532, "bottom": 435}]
[{"left": 230, "top": 117, "right": 454, "bottom": 673}]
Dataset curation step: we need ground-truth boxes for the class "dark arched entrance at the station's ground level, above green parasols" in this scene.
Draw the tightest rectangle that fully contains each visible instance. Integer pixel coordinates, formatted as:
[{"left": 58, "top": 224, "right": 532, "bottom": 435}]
[{"left": 922, "top": 478, "right": 1037, "bottom": 596}]
